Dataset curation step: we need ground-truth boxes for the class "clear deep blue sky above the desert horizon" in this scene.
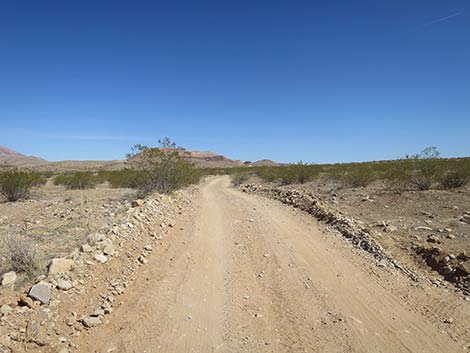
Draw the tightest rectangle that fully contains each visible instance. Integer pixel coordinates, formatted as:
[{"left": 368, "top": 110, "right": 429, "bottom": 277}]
[{"left": 0, "top": 0, "right": 470, "bottom": 162}]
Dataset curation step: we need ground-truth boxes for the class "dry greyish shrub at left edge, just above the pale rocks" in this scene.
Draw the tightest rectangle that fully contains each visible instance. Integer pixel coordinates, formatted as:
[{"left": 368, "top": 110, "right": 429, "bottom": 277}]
[{"left": 0, "top": 235, "right": 44, "bottom": 278}]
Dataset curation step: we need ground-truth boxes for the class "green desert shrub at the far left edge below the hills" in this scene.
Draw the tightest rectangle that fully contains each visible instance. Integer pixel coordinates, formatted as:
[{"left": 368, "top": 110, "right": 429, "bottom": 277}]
[{"left": 0, "top": 169, "right": 46, "bottom": 201}]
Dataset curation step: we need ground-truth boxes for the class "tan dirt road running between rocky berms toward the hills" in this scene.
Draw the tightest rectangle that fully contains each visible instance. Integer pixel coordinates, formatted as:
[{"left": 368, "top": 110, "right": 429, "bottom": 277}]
[{"left": 78, "top": 177, "right": 463, "bottom": 353}]
